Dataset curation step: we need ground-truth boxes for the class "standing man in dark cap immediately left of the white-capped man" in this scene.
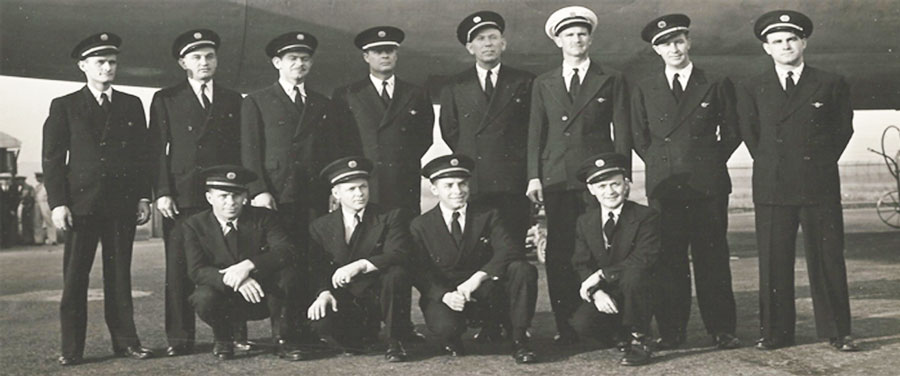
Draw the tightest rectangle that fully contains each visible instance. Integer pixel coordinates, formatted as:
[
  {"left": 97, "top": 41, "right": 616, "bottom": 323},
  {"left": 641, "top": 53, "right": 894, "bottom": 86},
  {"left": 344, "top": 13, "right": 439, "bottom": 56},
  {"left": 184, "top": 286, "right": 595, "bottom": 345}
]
[{"left": 441, "top": 11, "right": 534, "bottom": 296}]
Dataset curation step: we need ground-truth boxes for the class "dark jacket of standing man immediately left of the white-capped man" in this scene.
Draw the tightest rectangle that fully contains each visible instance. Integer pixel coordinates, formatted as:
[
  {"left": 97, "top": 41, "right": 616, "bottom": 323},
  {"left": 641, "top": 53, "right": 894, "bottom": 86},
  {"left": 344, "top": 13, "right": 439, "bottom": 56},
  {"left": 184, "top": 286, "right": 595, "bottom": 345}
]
[{"left": 441, "top": 65, "right": 534, "bottom": 195}]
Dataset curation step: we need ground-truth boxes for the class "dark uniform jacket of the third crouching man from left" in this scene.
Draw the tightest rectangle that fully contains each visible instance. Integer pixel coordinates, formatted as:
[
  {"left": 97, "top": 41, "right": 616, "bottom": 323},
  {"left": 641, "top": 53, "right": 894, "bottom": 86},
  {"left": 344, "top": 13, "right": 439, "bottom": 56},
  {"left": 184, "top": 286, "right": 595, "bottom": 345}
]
[{"left": 410, "top": 203, "right": 525, "bottom": 301}]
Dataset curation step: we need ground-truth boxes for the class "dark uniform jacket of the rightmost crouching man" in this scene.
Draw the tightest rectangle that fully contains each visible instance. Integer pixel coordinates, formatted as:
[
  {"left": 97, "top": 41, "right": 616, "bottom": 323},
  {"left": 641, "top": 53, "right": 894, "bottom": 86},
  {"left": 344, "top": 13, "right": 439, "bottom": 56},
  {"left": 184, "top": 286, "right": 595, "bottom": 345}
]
[{"left": 572, "top": 201, "right": 662, "bottom": 282}]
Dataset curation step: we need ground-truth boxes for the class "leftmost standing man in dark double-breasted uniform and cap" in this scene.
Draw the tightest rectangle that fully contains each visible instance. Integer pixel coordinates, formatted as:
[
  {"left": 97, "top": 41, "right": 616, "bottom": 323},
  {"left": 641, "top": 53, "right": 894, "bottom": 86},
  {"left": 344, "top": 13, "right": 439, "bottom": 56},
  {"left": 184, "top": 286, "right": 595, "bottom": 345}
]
[{"left": 43, "top": 32, "right": 152, "bottom": 365}]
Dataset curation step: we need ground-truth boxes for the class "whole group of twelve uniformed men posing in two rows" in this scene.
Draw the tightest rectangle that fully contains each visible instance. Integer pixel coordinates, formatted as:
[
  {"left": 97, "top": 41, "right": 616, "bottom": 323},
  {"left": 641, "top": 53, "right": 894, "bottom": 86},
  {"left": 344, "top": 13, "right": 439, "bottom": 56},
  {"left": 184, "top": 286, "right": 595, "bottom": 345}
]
[{"left": 43, "top": 2, "right": 856, "bottom": 365}]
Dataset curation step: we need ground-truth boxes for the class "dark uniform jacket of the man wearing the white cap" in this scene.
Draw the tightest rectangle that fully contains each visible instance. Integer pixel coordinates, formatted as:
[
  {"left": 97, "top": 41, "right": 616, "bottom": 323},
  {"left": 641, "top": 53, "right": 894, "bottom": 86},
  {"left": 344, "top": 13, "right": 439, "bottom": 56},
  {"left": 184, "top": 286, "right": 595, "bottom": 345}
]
[{"left": 528, "top": 62, "right": 631, "bottom": 191}]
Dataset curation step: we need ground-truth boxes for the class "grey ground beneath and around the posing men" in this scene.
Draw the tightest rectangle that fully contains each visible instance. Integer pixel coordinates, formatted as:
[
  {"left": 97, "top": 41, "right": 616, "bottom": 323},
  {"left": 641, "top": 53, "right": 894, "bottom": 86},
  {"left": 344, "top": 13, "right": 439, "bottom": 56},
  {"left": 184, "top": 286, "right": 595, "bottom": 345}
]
[{"left": 0, "top": 208, "right": 900, "bottom": 376}]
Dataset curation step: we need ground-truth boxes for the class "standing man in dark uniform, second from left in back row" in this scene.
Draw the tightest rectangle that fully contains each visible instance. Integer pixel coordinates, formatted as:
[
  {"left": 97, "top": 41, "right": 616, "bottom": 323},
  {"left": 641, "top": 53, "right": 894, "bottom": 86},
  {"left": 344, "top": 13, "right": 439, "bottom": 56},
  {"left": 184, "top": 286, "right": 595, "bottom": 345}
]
[{"left": 150, "top": 29, "right": 243, "bottom": 356}]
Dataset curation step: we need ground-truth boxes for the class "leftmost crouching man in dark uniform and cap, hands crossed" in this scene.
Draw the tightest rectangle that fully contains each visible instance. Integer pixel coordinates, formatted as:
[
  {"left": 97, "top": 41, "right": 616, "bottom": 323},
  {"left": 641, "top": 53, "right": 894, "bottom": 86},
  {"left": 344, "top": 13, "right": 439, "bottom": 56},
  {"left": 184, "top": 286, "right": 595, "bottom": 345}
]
[{"left": 182, "top": 165, "right": 305, "bottom": 361}]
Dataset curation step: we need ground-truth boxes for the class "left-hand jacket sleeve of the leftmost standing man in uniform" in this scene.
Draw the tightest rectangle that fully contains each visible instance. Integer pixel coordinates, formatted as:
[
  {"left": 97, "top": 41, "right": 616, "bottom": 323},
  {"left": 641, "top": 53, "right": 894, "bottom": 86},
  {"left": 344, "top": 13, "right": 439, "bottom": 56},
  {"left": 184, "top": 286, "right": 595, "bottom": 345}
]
[{"left": 41, "top": 98, "right": 71, "bottom": 209}]
